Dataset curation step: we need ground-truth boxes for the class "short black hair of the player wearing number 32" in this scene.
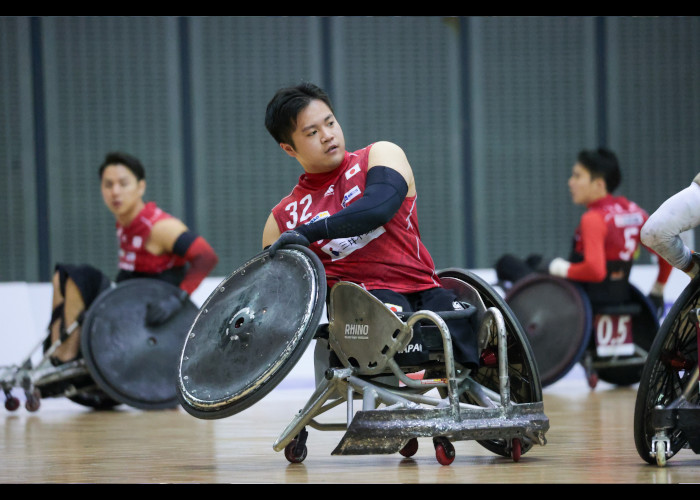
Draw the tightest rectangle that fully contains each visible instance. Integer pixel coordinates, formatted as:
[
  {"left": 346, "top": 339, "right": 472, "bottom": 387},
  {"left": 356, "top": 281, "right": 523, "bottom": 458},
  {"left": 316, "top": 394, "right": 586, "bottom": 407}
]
[{"left": 265, "top": 82, "right": 334, "bottom": 146}]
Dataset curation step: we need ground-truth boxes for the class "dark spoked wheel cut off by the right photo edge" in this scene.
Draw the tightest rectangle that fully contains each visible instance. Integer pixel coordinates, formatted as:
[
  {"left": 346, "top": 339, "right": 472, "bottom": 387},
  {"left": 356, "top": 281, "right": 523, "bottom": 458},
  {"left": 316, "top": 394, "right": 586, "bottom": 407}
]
[{"left": 634, "top": 276, "right": 700, "bottom": 464}]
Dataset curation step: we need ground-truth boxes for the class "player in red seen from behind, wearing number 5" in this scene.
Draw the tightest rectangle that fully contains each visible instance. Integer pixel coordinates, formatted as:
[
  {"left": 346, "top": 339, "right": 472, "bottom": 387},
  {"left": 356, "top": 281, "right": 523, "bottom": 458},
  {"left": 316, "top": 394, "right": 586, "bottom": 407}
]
[{"left": 495, "top": 148, "right": 671, "bottom": 314}]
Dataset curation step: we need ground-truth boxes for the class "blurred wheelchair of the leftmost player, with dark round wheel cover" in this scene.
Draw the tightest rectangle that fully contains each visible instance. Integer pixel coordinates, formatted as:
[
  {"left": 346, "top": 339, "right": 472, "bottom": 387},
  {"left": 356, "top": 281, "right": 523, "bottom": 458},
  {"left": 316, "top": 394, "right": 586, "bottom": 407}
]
[{"left": 0, "top": 278, "right": 198, "bottom": 412}]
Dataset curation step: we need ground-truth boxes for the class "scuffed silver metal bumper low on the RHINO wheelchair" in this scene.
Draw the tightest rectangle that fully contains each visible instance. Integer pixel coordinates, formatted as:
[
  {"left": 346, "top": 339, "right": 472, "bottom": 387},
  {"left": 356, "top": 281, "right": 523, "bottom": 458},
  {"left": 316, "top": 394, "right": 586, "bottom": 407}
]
[{"left": 332, "top": 402, "right": 549, "bottom": 455}]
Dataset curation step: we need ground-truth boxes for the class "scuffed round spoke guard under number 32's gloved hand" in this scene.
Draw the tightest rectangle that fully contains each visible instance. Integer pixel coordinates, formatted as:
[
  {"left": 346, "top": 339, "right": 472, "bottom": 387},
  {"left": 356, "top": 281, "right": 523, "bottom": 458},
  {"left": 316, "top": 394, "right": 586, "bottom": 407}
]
[{"left": 177, "top": 245, "right": 326, "bottom": 419}]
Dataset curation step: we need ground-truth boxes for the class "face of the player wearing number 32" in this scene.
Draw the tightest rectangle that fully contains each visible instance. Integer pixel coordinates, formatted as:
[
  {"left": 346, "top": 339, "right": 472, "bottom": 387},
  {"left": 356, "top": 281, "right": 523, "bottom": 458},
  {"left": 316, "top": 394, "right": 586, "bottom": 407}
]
[{"left": 280, "top": 99, "right": 345, "bottom": 173}]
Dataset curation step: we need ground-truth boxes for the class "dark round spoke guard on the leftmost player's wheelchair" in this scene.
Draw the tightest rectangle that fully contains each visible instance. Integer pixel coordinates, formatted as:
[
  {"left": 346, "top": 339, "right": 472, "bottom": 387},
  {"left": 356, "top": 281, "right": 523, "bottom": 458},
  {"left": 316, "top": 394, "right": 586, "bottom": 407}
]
[{"left": 80, "top": 278, "right": 197, "bottom": 410}]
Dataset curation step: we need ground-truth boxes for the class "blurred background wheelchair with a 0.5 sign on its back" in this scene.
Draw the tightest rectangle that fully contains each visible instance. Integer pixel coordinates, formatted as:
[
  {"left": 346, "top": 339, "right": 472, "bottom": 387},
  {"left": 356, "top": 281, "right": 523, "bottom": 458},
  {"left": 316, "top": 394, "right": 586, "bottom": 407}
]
[{"left": 505, "top": 273, "right": 659, "bottom": 389}]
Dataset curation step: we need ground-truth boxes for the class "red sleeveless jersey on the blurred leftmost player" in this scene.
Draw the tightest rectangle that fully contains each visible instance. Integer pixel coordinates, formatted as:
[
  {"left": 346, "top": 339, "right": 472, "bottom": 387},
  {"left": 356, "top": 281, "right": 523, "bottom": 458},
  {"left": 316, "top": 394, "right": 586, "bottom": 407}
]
[{"left": 116, "top": 201, "right": 186, "bottom": 274}]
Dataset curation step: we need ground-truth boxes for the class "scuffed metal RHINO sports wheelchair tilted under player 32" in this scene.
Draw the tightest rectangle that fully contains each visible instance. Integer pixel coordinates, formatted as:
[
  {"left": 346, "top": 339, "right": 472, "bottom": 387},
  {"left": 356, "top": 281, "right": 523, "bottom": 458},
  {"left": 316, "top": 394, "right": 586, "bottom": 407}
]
[{"left": 178, "top": 245, "right": 549, "bottom": 465}]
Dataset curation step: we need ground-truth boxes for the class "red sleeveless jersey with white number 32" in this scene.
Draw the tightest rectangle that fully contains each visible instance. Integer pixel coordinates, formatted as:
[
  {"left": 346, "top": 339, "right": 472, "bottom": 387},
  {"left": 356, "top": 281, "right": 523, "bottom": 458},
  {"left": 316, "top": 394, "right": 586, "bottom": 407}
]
[{"left": 272, "top": 145, "right": 439, "bottom": 293}]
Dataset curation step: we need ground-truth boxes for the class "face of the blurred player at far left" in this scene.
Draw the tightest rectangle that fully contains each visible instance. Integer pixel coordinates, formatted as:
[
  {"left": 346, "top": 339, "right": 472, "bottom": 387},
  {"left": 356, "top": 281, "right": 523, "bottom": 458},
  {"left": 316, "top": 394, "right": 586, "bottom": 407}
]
[{"left": 101, "top": 164, "right": 146, "bottom": 221}]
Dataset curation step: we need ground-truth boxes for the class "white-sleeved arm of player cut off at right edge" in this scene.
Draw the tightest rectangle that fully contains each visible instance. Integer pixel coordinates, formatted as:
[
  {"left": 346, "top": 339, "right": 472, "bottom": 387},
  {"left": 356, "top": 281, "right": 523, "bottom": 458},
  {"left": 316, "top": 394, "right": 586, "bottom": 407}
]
[{"left": 641, "top": 173, "right": 700, "bottom": 282}]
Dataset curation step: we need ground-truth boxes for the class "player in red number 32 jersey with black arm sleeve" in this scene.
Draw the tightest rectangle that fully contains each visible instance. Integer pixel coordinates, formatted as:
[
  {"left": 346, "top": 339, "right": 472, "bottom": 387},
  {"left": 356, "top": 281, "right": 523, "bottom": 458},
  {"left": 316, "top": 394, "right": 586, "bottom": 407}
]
[{"left": 262, "top": 83, "right": 479, "bottom": 367}]
